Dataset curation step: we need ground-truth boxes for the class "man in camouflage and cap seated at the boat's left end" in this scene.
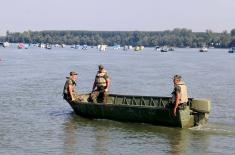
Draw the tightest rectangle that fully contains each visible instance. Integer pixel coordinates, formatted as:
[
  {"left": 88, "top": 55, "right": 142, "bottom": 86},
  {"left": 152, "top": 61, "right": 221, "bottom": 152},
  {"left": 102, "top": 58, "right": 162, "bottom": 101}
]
[{"left": 63, "top": 71, "right": 83, "bottom": 102}]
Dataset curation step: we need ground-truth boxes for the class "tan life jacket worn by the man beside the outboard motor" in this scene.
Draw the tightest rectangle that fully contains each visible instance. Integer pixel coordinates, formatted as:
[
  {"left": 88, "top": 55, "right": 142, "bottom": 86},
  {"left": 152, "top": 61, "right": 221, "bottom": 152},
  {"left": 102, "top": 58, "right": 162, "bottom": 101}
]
[{"left": 172, "top": 82, "right": 188, "bottom": 103}]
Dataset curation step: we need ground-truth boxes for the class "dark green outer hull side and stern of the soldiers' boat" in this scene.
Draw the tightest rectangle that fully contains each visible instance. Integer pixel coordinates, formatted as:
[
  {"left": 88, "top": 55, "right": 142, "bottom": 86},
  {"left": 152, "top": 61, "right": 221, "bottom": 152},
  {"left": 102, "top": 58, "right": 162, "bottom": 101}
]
[{"left": 66, "top": 94, "right": 196, "bottom": 128}]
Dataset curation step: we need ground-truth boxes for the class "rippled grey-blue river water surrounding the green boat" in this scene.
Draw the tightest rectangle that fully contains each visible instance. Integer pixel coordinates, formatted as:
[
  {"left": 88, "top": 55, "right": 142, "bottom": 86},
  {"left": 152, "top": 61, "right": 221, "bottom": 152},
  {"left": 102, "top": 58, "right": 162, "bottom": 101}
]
[{"left": 0, "top": 47, "right": 235, "bottom": 155}]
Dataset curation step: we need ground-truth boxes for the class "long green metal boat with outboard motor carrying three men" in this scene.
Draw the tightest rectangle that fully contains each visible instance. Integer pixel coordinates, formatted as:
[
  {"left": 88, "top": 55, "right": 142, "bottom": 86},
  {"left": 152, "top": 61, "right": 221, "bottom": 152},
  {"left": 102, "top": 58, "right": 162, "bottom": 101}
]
[{"left": 66, "top": 94, "right": 211, "bottom": 128}]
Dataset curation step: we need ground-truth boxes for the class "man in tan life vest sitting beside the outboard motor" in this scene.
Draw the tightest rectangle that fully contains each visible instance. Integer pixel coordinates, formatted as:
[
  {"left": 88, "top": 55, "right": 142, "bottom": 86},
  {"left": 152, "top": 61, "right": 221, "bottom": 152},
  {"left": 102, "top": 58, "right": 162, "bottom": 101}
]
[{"left": 171, "top": 75, "right": 188, "bottom": 116}]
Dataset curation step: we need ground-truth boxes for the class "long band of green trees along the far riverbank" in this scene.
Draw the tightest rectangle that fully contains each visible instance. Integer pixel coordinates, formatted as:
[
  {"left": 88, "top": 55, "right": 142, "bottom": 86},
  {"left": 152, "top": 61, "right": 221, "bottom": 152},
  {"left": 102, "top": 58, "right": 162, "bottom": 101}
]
[{"left": 0, "top": 28, "right": 235, "bottom": 48}]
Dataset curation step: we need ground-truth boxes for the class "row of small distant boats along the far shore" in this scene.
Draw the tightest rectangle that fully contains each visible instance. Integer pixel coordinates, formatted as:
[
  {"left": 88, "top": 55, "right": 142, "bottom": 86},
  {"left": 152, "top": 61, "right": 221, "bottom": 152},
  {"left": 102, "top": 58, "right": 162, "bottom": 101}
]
[{"left": 0, "top": 42, "right": 235, "bottom": 53}]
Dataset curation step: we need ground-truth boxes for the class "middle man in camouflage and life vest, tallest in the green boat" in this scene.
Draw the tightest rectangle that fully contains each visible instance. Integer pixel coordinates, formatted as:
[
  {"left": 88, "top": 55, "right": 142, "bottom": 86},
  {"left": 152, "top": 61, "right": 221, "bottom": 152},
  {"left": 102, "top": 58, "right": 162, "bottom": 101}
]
[{"left": 90, "top": 65, "right": 110, "bottom": 103}]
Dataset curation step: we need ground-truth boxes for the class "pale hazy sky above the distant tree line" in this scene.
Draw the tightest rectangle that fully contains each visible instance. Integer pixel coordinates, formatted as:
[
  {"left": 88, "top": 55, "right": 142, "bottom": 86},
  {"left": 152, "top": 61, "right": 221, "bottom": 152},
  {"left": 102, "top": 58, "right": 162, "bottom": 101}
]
[{"left": 0, "top": 0, "right": 235, "bottom": 35}]
